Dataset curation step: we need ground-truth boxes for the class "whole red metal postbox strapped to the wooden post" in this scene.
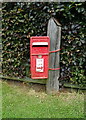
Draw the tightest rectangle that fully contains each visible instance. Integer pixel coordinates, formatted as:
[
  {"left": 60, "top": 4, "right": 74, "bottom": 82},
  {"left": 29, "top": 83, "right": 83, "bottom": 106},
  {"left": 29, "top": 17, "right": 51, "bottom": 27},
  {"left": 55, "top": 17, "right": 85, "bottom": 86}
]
[{"left": 30, "top": 36, "right": 50, "bottom": 79}]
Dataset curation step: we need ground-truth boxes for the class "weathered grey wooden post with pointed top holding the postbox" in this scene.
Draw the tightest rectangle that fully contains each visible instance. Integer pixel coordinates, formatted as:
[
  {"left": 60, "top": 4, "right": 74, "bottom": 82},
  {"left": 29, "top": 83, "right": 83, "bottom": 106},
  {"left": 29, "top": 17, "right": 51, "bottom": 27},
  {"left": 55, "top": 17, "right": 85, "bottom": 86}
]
[{"left": 46, "top": 18, "right": 61, "bottom": 94}]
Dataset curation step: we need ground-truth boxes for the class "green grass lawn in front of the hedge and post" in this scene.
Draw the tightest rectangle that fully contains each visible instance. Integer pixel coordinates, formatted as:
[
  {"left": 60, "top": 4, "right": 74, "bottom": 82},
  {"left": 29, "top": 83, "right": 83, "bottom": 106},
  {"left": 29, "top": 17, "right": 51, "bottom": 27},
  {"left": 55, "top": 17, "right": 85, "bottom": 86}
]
[{"left": 2, "top": 81, "right": 84, "bottom": 118}]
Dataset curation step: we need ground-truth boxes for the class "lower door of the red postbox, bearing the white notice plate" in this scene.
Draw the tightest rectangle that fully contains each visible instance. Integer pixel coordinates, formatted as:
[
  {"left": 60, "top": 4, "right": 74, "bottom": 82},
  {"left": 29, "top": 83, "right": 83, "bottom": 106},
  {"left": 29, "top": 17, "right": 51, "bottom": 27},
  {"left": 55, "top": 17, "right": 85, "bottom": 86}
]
[{"left": 31, "top": 55, "right": 48, "bottom": 79}]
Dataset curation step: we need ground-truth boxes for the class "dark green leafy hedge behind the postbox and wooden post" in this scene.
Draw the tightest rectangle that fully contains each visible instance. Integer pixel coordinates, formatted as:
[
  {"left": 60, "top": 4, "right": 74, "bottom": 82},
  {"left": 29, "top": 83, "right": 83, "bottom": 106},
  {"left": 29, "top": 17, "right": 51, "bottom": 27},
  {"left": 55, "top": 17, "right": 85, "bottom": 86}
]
[{"left": 2, "top": 2, "right": 86, "bottom": 86}]
